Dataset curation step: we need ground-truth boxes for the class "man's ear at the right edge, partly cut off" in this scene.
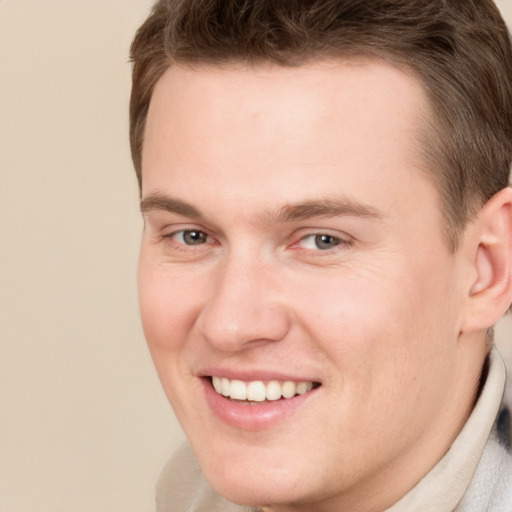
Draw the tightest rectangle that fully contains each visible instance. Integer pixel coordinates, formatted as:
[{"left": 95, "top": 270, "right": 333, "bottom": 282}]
[{"left": 462, "top": 187, "right": 512, "bottom": 332}]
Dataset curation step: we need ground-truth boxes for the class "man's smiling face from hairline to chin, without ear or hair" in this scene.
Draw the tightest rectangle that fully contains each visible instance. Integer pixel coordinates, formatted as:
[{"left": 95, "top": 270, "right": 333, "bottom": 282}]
[{"left": 139, "top": 61, "right": 470, "bottom": 511}]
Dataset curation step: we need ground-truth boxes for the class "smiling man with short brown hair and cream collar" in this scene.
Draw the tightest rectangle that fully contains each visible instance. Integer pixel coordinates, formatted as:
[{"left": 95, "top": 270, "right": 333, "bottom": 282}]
[{"left": 131, "top": 0, "right": 512, "bottom": 512}]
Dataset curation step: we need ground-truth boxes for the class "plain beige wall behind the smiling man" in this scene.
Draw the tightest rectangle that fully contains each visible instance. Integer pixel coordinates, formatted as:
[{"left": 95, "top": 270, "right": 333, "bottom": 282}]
[{"left": 0, "top": 0, "right": 512, "bottom": 512}]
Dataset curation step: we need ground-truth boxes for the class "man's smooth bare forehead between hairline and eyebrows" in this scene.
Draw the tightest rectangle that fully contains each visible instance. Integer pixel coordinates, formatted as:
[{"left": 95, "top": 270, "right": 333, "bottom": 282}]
[{"left": 142, "top": 60, "right": 434, "bottom": 218}]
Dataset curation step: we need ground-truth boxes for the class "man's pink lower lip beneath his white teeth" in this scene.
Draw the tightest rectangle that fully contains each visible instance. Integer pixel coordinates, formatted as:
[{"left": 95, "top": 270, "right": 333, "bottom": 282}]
[{"left": 201, "top": 378, "right": 318, "bottom": 430}]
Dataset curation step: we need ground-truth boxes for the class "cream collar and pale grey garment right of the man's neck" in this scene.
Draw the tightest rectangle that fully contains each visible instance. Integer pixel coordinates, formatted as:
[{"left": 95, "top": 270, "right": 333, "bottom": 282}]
[{"left": 387, "top": 348, "right": 512, "bottom": 512}]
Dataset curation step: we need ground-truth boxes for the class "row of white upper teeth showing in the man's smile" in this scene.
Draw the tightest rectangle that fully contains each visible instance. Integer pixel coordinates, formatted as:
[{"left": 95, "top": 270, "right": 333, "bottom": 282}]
[{"left": 212, "top": 377, "right": 313, "bottom": 402}]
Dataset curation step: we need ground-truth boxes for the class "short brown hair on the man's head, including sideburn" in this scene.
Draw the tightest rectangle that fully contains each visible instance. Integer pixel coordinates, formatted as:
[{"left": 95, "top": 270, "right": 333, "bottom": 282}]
[{"left": 130, "top": 0, "right": 512, "bottom": 250}]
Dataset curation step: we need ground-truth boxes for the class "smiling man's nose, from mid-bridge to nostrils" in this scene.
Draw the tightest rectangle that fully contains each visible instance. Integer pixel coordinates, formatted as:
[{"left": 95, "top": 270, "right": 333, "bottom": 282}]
[{"left": 197, "top": 253, "right": 290, "bottom": 352}]
